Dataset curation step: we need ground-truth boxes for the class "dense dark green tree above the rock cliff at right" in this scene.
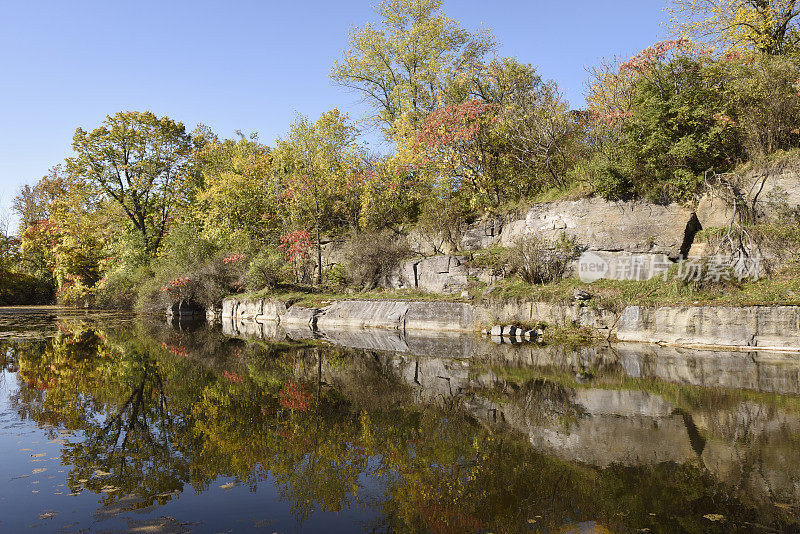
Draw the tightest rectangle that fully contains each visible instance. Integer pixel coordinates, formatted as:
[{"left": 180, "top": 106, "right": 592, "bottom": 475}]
[{"left": 592, "top": 57, "right": 744, "bottom": 202}]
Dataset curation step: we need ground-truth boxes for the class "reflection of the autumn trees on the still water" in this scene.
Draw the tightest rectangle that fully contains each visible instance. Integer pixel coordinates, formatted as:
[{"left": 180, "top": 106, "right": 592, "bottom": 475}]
[{"left": 6, "top": 322, "right": 800, "bottom": 532}]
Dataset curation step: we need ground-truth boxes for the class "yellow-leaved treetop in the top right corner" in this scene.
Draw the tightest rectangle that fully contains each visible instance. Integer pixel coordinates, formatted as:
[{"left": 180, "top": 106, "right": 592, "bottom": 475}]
[{"left": 668, "top": 0, "right": 800, "bottom": 55}]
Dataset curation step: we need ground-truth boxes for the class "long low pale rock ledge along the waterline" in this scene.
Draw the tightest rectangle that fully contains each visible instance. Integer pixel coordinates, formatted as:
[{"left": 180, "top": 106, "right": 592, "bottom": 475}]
[{"left": 222, "top": 298, "right": 800, "bottom": 352}]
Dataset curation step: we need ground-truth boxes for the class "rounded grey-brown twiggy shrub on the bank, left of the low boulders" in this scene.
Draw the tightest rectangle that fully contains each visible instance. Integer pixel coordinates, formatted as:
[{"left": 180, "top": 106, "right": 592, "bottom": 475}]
[{"left": 346, "top": 231, "right": 411, "bottom": 290}]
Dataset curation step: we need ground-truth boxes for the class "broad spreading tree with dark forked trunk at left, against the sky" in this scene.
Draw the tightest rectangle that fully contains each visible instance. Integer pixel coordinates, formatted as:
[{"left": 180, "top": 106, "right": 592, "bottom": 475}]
[{"left": 67, "top": 111, "right": 192, "bottom": 255}]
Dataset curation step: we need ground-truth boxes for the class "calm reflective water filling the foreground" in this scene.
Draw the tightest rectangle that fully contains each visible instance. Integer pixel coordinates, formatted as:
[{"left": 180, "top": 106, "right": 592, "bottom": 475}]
[{"left": 0, "top": 309, "right": 800, "bottom": 532}]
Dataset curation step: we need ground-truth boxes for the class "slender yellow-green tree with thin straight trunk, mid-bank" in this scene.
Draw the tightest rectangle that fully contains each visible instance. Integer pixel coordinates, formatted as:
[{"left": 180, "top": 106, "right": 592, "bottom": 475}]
[{"left": 274, "top": 108, "right": 359, "bottom": 282}]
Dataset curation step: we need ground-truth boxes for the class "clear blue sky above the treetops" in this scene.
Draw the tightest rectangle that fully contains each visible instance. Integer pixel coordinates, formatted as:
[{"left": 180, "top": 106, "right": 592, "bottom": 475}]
[{"left": 0, "top": 0, "right": 667, "bottom": 230}]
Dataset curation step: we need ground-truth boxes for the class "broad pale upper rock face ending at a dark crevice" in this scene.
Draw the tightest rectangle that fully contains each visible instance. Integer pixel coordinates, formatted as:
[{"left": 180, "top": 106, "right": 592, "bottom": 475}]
[{"left": 500, "top": 198, "right": 696, "bottom": 258}]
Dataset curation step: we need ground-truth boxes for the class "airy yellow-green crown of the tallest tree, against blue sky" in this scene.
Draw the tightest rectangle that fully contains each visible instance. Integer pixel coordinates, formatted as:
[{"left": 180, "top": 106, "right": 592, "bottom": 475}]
[{"left": 331, "top": 0, "right": 494, "bottom": 139}]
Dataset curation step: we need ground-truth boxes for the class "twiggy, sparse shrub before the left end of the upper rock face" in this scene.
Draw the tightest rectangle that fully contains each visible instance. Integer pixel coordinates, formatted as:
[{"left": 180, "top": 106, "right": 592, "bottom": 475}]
[{"left": 508, "top": 234, "right": 581, "bottom": 284}]
